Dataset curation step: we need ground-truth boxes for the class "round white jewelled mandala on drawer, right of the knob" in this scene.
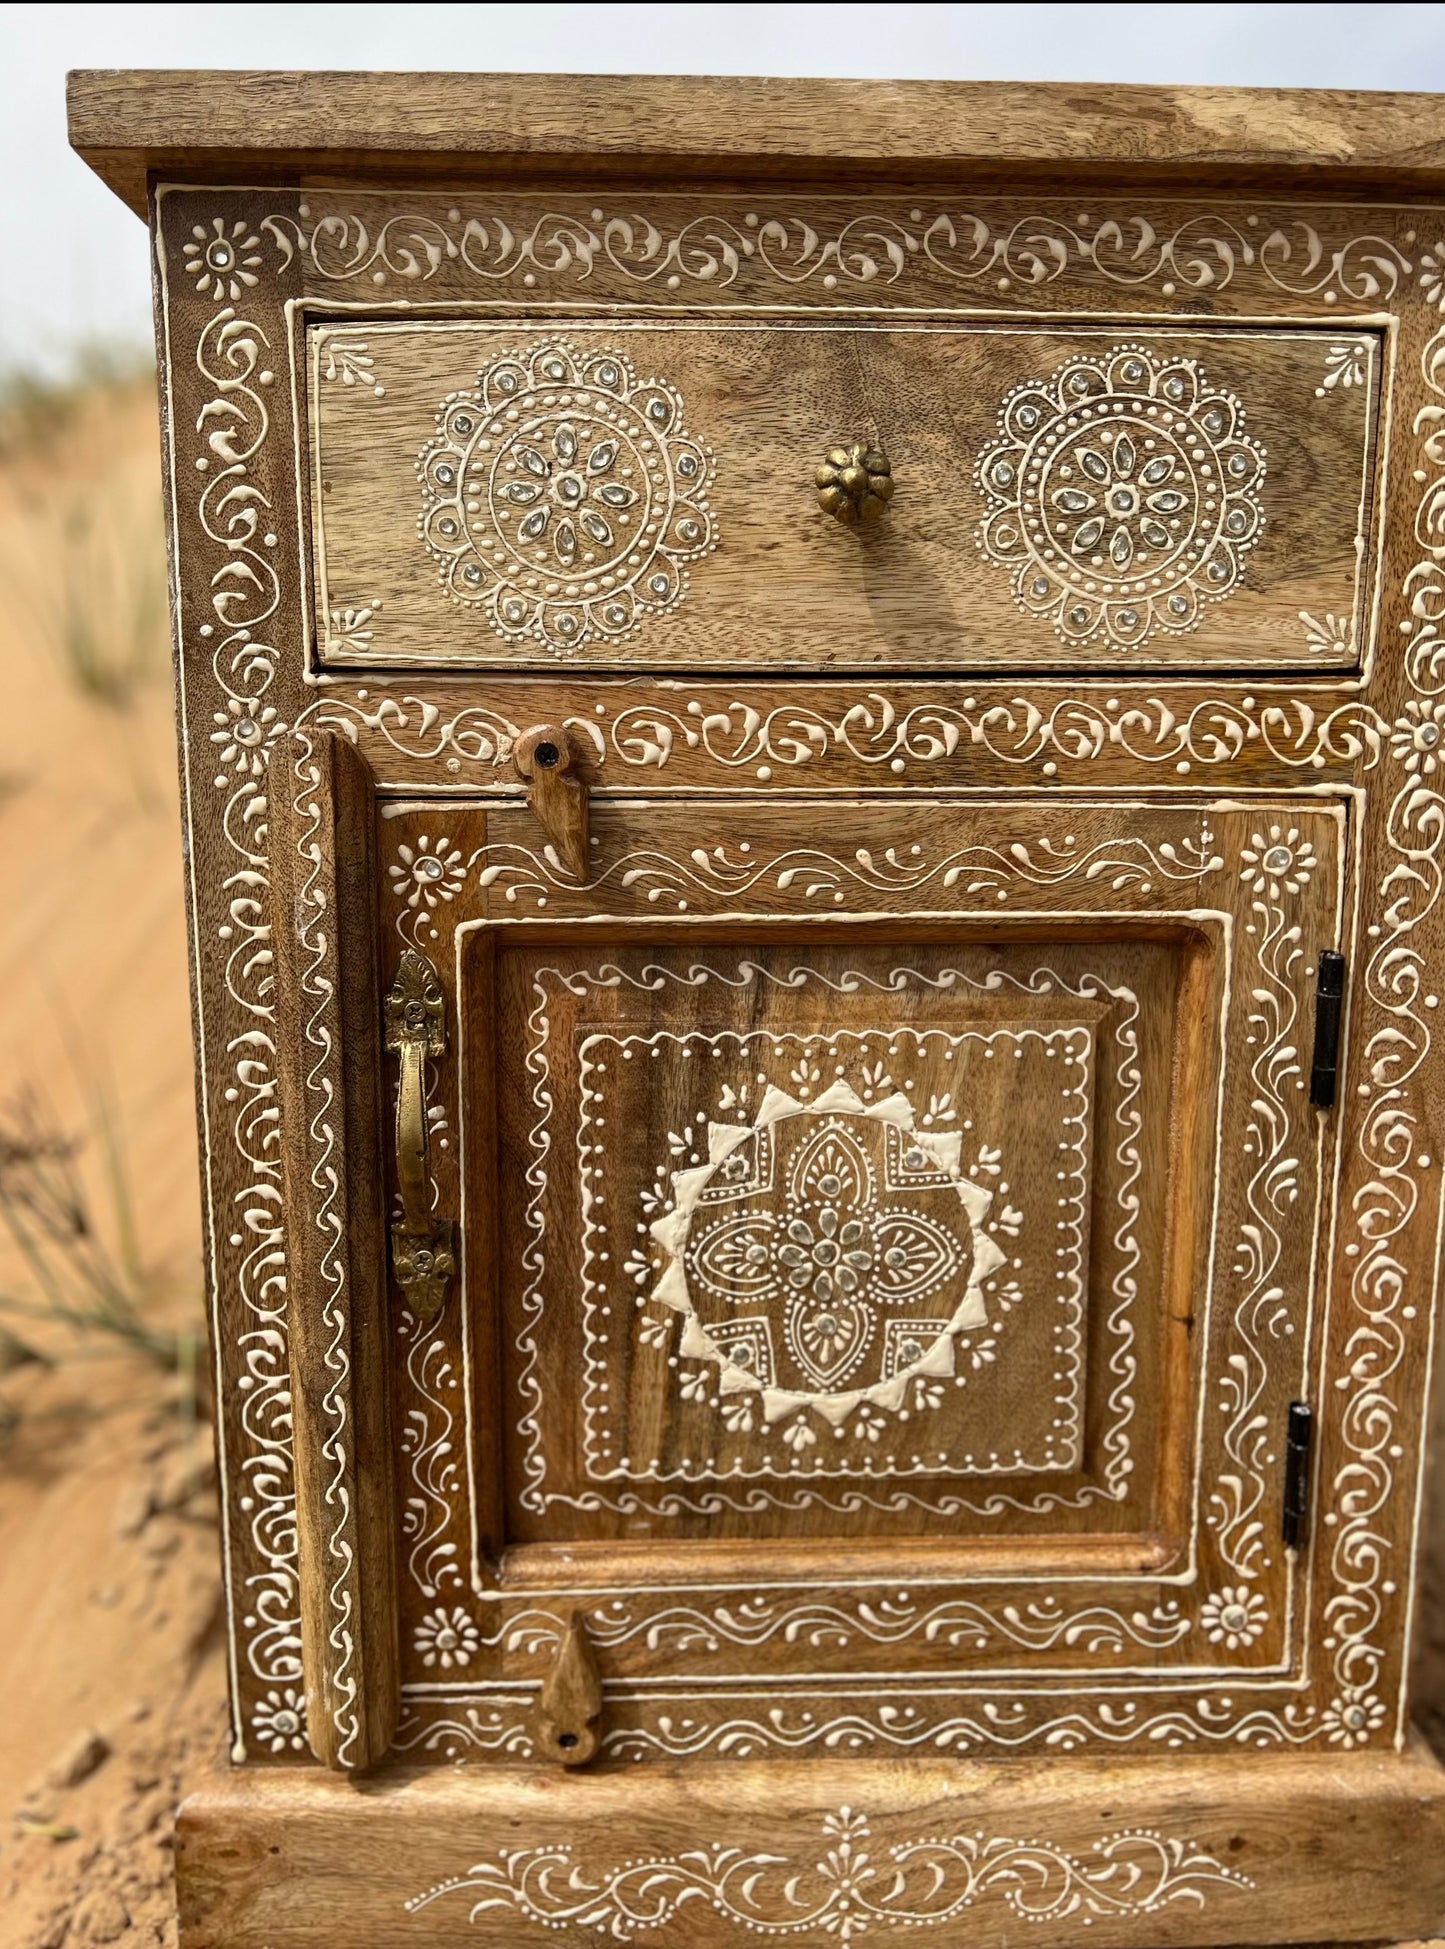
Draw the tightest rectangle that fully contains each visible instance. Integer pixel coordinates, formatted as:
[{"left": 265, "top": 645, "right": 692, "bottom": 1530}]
[{"left": 977, "top": 345, "right": 1266, "bottom": 649}]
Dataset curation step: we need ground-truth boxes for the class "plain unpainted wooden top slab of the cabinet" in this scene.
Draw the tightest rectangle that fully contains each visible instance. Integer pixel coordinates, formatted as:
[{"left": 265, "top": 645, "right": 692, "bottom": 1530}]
[{"left": 68, "top": 68, "right": 1445, "bottom": 214}]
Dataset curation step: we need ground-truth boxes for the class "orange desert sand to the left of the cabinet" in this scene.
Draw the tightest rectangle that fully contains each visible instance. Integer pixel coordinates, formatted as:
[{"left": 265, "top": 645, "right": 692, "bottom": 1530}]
[{"left": 0, "top": 386, "right": 224, "bottom": 1949}]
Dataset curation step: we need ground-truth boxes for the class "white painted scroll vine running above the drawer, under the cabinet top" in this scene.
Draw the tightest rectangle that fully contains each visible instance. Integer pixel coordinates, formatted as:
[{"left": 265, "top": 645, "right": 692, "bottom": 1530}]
[{"left": 219, "top": 199, "right": 1439, "bottom": 304}]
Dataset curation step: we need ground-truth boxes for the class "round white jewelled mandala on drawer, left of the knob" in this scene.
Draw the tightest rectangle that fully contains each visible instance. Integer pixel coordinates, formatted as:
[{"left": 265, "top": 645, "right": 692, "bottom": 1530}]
[{"left": 417, "top": 341, "right": 718, "bottom": 655}]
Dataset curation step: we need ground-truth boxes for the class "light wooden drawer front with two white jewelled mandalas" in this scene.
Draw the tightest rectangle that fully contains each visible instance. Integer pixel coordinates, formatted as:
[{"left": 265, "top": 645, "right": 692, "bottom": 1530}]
[{"left": 308, "top": 320, "right": 1386, "bottom": 674}]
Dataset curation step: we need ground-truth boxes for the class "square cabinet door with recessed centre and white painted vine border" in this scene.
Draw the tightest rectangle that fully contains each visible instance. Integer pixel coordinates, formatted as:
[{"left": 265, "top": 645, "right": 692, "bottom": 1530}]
[{"left": 358, "top": 779, "right": 1347, "bottom": 1758}]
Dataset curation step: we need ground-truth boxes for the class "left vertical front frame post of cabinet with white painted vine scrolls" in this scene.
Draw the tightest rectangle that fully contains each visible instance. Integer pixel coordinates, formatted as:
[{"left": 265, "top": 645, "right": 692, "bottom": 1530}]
[{"left": 154, "top": 187, "right": 306, "bottom": 1764}]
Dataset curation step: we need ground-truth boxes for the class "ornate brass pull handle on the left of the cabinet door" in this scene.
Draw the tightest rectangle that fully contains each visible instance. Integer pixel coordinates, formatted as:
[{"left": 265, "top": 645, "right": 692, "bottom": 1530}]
[{"left": 386, "top": 947, "right": 456, "bottom": 1321}]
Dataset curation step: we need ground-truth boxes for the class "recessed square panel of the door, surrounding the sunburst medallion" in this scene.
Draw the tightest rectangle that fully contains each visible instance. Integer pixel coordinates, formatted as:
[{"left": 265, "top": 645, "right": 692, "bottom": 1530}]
[{"left": 497, "top": 930, "right": 1191, "bottom": 1542}]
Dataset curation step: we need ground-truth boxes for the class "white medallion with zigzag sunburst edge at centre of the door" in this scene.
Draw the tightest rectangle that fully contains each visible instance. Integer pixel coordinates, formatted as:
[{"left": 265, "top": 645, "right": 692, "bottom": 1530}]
[{"left": 651, "top": 1082, "right": 1004, "bottom": 1429}]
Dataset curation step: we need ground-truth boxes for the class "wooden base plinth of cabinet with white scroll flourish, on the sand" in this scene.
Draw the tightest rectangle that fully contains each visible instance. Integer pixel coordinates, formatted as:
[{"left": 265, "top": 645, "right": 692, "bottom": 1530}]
[{"left": 176, "top": 1752, "right": 1445, "bottom": 1949}]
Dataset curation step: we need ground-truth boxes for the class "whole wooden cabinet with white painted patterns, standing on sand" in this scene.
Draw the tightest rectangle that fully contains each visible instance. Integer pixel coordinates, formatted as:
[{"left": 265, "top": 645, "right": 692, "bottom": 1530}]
[{"left": 72, "top": 76, "right": 1445, "bottom": 1949}]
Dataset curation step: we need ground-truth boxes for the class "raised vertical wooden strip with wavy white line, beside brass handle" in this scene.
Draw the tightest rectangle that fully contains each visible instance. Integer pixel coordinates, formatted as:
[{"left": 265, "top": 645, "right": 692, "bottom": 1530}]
[{"left": 267, "top": 731, "right": 398, "bottom": 1770}]
